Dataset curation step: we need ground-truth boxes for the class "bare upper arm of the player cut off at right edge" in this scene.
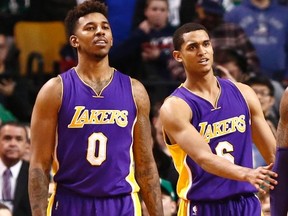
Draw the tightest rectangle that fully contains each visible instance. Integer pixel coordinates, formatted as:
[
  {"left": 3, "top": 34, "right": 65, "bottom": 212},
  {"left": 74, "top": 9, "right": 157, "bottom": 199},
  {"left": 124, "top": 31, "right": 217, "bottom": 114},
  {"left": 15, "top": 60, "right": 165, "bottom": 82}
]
[{"left": 277, "top": 88, "right": 288, "bottom": 148}]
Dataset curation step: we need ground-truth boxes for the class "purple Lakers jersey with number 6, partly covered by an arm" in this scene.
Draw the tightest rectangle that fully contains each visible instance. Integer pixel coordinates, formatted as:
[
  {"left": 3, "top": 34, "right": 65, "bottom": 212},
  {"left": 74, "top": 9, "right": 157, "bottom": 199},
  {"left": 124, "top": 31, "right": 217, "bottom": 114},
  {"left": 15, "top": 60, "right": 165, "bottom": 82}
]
[{"left": 167, "top": 78, "right": 256, "bottom": 201}]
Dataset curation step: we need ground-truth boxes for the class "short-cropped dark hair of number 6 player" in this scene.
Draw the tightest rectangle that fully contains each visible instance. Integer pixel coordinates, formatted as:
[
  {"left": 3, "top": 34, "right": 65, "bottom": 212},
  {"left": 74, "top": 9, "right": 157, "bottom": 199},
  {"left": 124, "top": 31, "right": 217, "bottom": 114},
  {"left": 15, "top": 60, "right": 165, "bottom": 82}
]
[{"left": 173, "top": 22, "right": 209, "bottom": 50}]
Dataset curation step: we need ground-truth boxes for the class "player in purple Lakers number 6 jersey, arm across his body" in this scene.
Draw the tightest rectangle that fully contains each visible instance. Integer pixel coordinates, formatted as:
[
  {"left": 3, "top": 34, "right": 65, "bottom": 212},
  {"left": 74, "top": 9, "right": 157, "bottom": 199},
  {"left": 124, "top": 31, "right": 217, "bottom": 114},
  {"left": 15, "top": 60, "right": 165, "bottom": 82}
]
[{"left": 160, "top": 23, "right": 277, "bottom": 216}]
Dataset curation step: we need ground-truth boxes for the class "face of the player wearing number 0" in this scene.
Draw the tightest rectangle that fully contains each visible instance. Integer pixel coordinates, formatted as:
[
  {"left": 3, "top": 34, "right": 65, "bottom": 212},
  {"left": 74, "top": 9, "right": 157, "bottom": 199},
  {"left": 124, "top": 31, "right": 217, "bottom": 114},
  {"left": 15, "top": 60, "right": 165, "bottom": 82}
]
[{"left": 70, "top": 13, "right": 112, "bottom": 58}]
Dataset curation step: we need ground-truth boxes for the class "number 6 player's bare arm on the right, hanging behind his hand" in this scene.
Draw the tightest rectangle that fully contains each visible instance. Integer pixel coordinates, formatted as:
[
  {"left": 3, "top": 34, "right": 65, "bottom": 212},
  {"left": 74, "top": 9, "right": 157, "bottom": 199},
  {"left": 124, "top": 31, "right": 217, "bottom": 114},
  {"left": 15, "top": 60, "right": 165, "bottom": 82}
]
[{"left": 237, "top": 83, "right": 276, "bottom": 164}]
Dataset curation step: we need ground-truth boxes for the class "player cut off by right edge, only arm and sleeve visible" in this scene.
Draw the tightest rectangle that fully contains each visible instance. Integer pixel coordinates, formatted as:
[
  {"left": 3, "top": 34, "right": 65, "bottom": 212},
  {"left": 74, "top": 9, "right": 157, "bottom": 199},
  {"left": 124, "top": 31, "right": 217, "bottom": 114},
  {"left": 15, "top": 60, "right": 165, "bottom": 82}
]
[{"left": 270, "top": 88, "right": 288, "bottom": 216}]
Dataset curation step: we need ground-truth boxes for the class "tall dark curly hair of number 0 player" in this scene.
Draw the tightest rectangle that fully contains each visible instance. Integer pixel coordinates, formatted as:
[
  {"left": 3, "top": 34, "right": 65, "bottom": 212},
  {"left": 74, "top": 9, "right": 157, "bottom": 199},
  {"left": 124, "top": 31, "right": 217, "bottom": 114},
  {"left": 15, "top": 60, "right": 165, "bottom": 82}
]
[{"left": 64, "top": 0, "right": 108, "bottom": 38}]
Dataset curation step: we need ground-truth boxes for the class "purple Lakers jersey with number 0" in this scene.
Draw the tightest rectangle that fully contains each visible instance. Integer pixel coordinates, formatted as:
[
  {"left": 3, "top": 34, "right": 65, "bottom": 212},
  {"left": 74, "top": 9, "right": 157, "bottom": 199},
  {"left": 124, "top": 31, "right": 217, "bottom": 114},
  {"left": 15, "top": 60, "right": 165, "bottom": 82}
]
[{"left": 53, "top": 68, "right": 139, "bottom": 197}]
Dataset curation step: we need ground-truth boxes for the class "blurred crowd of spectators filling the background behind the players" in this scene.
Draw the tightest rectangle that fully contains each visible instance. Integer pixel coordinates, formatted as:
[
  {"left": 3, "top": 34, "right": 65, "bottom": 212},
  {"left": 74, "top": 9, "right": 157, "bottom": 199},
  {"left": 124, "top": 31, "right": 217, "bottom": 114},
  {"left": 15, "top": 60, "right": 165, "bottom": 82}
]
[{"left": 0, "top": 0, "right": 288, "bottom": 216}]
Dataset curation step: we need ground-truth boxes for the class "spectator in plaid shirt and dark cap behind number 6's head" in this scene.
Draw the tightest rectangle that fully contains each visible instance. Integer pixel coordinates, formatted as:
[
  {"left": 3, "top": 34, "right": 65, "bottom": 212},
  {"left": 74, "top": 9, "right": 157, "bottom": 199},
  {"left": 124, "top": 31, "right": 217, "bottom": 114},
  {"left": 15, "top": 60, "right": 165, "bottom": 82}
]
[{"left": 196, "top": 0, "right": 259, "bottom": 73}]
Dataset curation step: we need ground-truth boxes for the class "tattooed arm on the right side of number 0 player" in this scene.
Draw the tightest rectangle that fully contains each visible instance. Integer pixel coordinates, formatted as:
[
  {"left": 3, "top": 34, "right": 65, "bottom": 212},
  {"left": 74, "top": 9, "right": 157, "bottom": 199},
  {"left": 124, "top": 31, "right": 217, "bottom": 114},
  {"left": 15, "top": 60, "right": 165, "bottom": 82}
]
[{"left": 132, "top": 80, "right": 163, "bottom": 216}]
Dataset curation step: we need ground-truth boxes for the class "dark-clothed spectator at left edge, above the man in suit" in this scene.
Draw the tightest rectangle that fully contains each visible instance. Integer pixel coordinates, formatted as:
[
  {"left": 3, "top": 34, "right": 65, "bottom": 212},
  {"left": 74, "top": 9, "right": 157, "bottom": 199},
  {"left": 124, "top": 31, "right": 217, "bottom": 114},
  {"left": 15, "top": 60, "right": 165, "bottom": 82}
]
[{"left": 0, "top": 34, "right": 34, "bottom": 122}]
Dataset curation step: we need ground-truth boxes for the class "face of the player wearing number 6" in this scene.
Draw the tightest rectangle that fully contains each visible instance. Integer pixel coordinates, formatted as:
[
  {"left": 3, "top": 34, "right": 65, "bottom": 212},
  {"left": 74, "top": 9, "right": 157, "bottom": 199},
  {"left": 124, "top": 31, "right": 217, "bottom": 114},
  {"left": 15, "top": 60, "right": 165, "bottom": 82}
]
[{"left": 173, "top": 30, "right": 214, "bottom": 75}]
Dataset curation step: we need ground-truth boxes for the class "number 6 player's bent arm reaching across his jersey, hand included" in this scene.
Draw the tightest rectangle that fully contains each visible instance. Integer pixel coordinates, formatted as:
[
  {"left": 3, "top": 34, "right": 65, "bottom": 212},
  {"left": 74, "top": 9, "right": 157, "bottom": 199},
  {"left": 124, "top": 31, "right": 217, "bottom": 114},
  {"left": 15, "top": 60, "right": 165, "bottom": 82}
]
[{"left": 160, "top": 97, "right": 276, "bottom": 192}]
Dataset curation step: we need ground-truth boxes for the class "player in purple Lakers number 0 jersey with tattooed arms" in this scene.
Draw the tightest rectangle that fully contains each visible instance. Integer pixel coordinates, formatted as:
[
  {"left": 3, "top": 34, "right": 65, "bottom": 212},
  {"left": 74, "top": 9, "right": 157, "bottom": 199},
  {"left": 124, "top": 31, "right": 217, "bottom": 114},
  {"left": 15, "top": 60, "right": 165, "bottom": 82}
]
[{"left": 29, "top": 0, "right": 163, "bottom": 216}]
